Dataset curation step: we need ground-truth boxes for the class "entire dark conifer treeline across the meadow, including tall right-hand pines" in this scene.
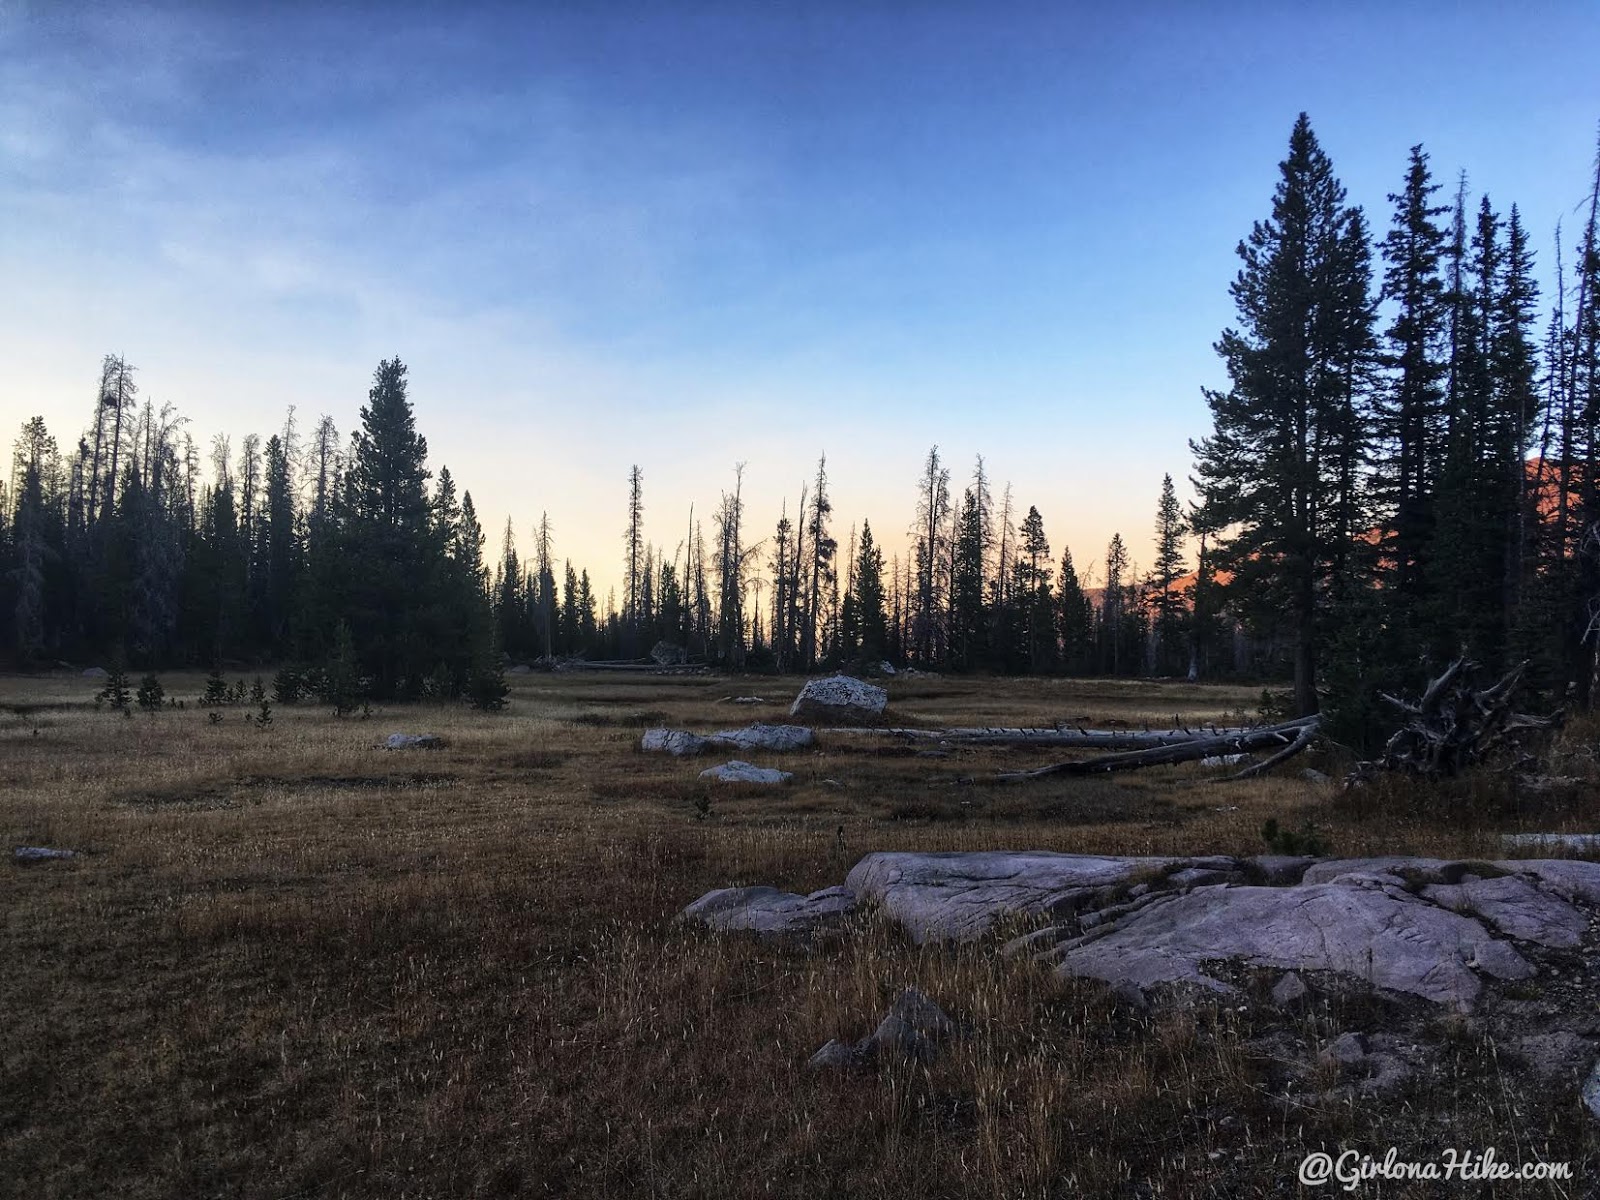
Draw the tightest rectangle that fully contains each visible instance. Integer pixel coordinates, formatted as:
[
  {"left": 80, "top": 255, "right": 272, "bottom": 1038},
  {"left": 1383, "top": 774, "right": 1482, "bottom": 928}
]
[{"left": 0, "top": 115, "right": 1600, "bottom": 741}]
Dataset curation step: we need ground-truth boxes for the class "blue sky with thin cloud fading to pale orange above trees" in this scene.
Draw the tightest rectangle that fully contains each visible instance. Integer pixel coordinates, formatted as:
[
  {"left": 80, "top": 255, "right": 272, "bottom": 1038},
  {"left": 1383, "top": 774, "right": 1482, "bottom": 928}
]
[{"left": 0, "top": 0, "right": 1600, "bottom": 595}]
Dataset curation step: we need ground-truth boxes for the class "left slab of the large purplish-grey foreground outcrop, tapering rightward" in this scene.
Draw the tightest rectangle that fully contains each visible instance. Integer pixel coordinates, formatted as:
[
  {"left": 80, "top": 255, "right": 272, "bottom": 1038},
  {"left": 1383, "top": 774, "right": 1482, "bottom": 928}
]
[{"left": 845, "top": 851, "right": 1203, "bottom": 942}]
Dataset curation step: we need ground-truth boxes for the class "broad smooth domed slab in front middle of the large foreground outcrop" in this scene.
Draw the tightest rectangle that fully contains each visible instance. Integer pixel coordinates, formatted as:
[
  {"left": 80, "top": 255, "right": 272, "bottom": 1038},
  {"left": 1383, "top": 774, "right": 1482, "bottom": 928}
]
[{"left": 1040, "top": 883, "right": 1533, "bottom": 1010}]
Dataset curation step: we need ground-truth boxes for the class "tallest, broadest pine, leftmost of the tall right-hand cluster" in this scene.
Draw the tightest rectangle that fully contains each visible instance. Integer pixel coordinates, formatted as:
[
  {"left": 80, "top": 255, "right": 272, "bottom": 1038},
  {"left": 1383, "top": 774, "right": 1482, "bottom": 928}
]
[{"left": 1192, "top": 114, "right": 1373, "bottom": 712}]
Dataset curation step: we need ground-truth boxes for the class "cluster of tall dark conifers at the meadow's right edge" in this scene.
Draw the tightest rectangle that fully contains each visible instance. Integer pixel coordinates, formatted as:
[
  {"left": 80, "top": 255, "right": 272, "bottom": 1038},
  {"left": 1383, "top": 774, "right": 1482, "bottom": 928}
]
[{"left": 1192, "top": 114, "right": 1600, "bottom": 741}]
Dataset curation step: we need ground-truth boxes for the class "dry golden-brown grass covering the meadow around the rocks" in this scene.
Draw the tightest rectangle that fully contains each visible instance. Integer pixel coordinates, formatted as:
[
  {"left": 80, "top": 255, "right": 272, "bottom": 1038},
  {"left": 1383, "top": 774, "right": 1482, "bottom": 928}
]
[{"left": 0, "top": 675, "right": 1597, "bottom": 1200}]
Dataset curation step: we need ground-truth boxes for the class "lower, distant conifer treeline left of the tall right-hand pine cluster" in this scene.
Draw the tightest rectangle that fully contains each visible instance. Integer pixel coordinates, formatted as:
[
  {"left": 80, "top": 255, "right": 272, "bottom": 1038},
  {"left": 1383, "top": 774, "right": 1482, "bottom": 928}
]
[{"left": 0, "top": 357, "right": 1192, "bottom": 684}]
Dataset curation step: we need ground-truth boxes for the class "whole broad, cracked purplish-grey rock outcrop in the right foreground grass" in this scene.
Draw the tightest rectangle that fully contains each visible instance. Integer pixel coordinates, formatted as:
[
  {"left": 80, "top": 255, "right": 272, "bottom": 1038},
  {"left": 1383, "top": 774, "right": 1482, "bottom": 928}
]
[{"left": 700, "top": 851, "right": 1600, "bottom": 1017}]
